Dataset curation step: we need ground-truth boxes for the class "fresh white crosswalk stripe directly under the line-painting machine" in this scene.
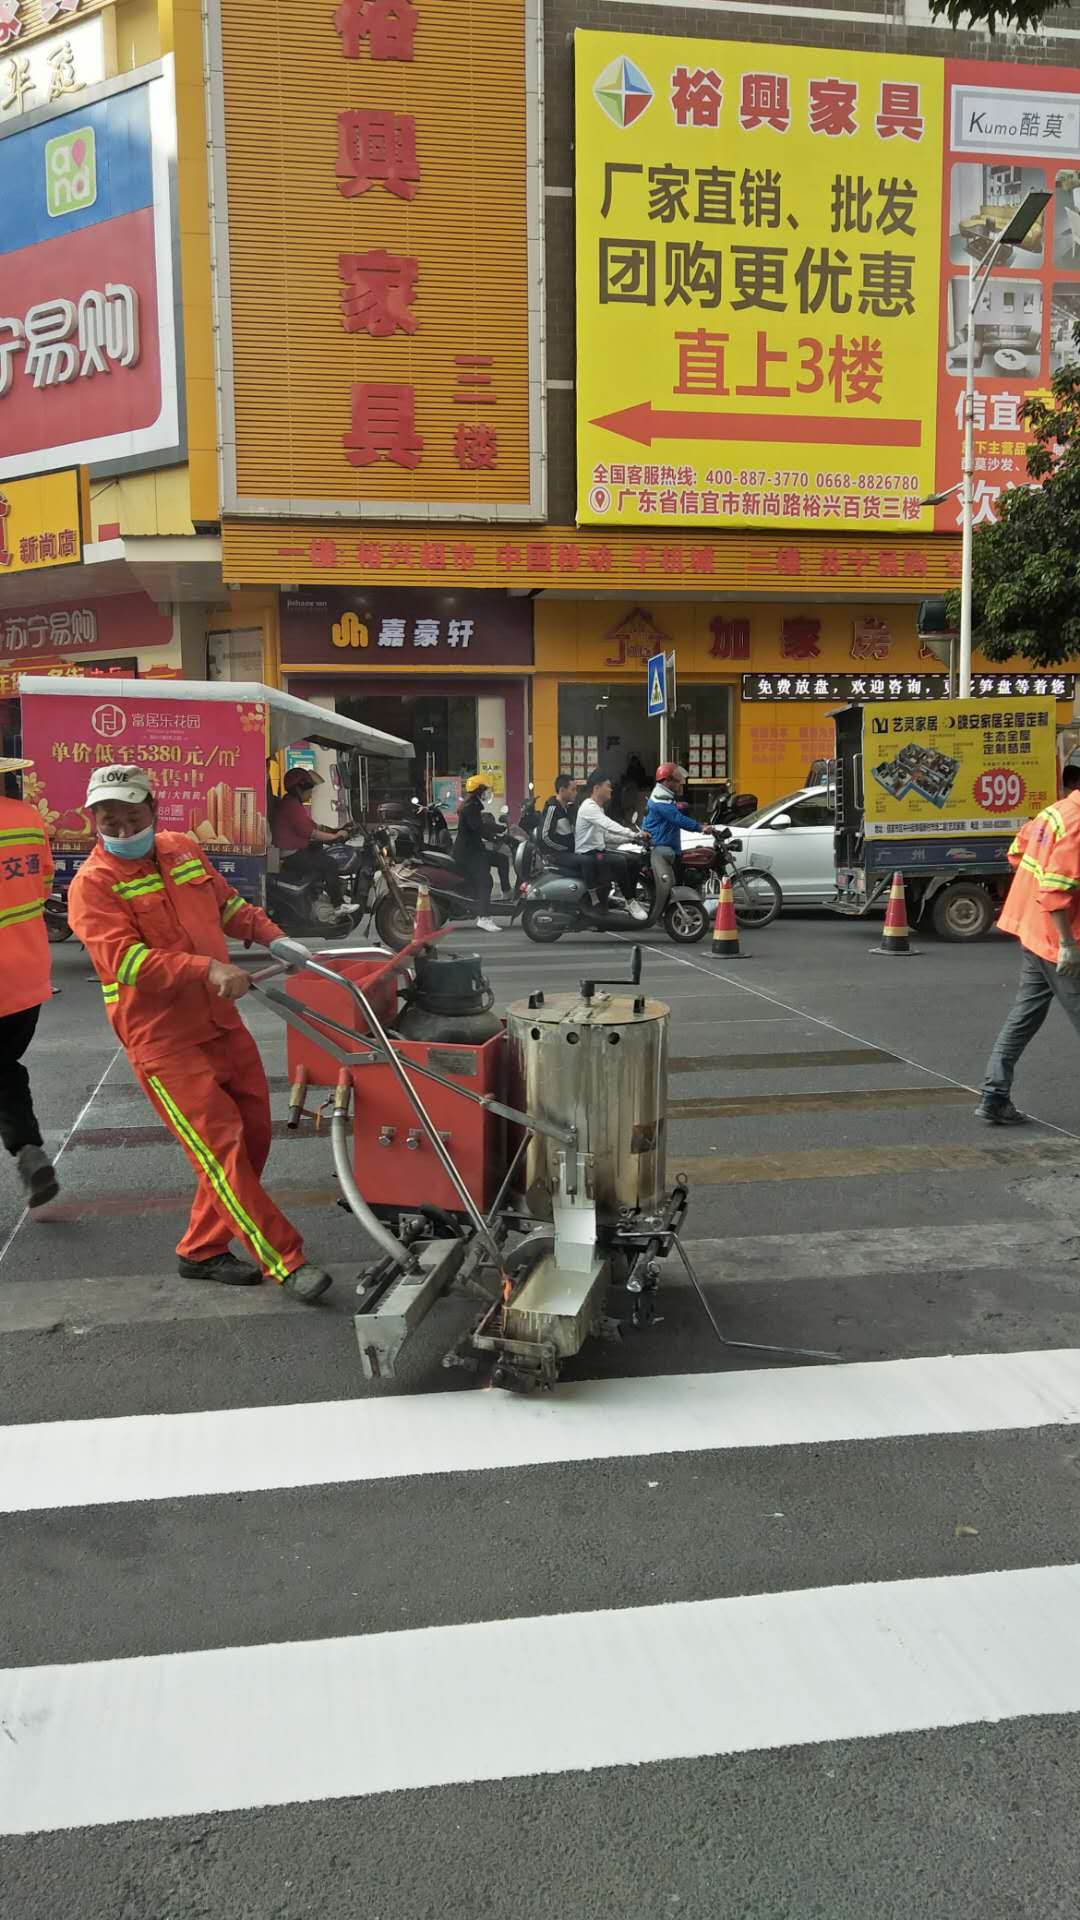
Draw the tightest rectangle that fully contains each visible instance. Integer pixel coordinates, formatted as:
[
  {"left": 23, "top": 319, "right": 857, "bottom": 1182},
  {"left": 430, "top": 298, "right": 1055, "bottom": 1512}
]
[{"left": 0, "top": 1348, "right": 1080, "bottom": 1513}]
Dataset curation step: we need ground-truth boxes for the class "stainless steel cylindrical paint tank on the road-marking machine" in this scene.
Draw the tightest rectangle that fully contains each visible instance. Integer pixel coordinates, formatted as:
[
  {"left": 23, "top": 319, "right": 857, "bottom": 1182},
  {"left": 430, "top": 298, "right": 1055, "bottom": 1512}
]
[{"left": 507, "top": 993, "right": 669, "bottom": 1221}]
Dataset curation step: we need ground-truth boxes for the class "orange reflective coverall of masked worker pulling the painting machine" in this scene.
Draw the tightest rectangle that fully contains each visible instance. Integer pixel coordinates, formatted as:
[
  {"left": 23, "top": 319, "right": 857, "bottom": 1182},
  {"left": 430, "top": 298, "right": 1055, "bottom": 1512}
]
[{"left": 67, "top": 833, "right": 304, "bottom": 1281}]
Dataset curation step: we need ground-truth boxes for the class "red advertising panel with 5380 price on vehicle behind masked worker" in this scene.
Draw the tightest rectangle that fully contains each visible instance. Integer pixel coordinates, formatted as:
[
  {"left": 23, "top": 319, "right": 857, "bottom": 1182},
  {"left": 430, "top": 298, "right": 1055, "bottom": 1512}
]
[{"left": 23, "top": 687, "right": 267, "bottom": 893}]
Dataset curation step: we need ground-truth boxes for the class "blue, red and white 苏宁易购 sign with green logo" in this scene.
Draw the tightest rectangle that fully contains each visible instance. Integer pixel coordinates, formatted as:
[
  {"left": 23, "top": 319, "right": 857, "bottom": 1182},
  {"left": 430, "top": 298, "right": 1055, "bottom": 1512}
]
[{"left": 0, "top": 56, "right": 183, "bottom": 482}]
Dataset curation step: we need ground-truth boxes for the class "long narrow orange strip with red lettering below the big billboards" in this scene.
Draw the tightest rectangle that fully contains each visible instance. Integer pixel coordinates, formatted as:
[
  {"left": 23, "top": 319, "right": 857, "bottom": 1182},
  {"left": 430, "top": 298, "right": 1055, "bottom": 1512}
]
[{"left": 221, "top": 520, "right": 961, "bottom": 599}]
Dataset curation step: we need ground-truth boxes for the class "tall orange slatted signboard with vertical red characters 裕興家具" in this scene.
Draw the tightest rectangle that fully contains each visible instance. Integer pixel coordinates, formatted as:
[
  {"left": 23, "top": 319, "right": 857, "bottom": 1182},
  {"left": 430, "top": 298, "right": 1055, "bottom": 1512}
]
[{"left": 211, "top": 0, "right": 544, "bottom": 518}]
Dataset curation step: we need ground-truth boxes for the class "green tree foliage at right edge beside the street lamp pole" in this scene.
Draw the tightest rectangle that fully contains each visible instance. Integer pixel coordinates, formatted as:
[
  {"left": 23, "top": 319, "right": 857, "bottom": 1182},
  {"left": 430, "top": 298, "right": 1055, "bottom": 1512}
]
[{"left": 947, "top": 326, "right": 1080, "bottom": 666}]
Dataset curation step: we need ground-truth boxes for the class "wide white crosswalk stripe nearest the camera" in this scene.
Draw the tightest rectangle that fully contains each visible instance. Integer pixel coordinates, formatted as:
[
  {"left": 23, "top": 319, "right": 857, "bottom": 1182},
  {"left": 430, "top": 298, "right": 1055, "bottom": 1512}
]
[{"left": 0, "top": 1567, "right": 1080, "bottom": 1834}]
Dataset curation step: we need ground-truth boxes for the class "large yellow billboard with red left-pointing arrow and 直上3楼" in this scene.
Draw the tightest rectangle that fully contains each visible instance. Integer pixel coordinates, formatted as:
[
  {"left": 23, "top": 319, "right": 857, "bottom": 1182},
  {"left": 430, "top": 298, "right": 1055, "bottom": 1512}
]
[{"left": 575, "top": 31, "right": 944, "bottom": 532}]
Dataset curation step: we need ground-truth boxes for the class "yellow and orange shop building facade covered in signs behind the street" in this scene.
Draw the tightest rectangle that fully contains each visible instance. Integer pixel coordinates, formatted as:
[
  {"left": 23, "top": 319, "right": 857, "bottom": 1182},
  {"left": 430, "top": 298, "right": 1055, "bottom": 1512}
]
[{"left": 31, "top": 0, "right": 1060, "bottom": 804}]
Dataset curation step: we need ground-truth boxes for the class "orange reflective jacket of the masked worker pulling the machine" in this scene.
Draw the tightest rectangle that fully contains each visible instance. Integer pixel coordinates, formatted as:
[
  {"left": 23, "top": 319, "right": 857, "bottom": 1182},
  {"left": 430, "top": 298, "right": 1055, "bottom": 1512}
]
[{"left": 67, "top": 833, "right": 281, "bottom": 1068}]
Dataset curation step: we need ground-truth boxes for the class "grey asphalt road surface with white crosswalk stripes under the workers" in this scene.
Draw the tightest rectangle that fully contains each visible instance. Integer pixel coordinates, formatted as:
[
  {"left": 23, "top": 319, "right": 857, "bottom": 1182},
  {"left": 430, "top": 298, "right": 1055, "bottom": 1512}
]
[{"left": 0, "top": 916, "right": 1080, "bottom": 1920}]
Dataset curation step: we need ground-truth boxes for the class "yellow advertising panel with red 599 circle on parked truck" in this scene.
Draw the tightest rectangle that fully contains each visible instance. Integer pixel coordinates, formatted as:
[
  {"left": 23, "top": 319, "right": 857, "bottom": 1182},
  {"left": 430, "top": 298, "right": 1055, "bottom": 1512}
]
[{"left": 863, "top": 699, "right": 1057, "bottom": 839}]
